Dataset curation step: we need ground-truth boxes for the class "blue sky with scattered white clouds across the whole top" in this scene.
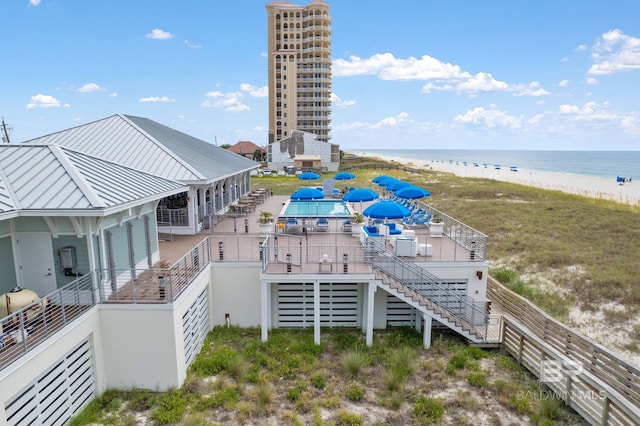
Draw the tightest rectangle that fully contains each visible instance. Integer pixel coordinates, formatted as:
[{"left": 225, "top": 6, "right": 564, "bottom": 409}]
[{"left": 0, "top": 0, "right": 640, "bottom": 150}]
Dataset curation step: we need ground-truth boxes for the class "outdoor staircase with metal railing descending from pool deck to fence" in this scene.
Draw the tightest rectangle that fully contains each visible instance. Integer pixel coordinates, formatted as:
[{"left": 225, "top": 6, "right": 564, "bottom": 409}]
[{"left": 371, "top": 250, "right": 491, "bottom": 344}]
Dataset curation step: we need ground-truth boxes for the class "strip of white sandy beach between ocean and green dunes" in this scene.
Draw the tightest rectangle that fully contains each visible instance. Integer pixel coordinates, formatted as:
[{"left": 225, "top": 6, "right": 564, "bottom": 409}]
[{"left": 360, "top": 152, "right": 640, "bottom": 206}]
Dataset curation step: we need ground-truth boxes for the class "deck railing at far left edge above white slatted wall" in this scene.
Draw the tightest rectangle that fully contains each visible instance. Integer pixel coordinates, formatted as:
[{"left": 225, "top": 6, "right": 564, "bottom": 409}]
[{"left": 0, "top": 275, "right": 97, "bottom": 370}]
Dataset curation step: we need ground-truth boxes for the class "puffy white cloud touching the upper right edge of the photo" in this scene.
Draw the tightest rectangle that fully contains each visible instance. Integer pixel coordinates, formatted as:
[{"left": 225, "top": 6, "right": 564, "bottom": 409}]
[{"left": 589, "top": 29, "right": 640, "bottom": 75}]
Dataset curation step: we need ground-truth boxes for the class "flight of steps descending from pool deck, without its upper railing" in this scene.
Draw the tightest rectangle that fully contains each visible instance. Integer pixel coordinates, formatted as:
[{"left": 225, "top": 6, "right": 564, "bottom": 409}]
[{"left": 374, "top": 269, "right": 487, "bottom": 343}]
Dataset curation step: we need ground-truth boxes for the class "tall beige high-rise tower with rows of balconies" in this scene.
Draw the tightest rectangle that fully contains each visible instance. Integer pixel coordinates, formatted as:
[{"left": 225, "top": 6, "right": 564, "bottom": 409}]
[{"left": 266, "top": 0, "right": 331, "bottom": 143}]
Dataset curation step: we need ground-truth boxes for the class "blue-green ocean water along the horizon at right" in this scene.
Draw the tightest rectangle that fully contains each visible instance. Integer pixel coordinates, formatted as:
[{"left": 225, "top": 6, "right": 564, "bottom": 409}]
[{"left": 347, "top": 149, "right": 640, "bottom": 181}]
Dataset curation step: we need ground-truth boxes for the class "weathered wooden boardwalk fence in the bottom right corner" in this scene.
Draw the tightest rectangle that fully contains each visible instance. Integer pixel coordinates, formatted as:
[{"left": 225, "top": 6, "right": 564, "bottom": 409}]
[{"left": 487, "top": 277, "right": 640, "bottom": 425}]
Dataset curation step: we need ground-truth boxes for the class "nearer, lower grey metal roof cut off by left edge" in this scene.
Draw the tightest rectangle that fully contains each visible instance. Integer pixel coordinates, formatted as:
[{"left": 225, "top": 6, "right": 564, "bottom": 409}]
[{"left": 0, "top": 144, "right": 187, "bottom": 217}]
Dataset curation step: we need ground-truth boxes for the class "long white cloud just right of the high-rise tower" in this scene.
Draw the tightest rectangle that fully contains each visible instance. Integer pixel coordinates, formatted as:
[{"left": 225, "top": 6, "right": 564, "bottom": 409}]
[{"left": 332, "top": 53, "right": 549, "bottom": 96}]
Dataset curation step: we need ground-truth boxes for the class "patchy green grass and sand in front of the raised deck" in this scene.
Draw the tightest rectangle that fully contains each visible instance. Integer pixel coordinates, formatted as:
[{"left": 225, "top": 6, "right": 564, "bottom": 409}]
[{"left": 70, "top": 327, "right": 580, "bottom": 426}]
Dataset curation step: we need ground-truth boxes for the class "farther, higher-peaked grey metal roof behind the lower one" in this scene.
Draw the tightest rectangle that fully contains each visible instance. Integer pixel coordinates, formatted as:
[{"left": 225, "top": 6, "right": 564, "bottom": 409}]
[{"left": 26, "top": 114, "right": 260, "bottom": 182}]
